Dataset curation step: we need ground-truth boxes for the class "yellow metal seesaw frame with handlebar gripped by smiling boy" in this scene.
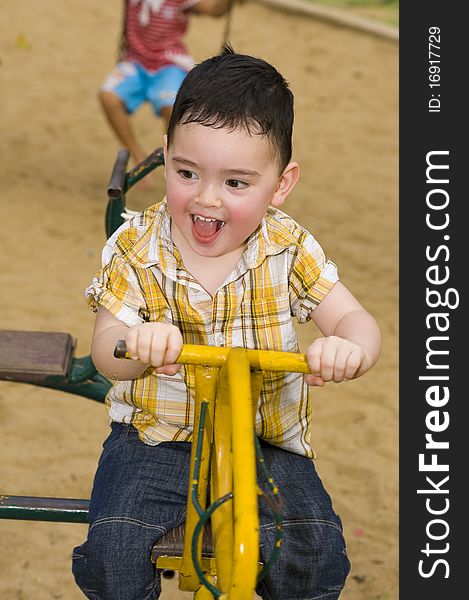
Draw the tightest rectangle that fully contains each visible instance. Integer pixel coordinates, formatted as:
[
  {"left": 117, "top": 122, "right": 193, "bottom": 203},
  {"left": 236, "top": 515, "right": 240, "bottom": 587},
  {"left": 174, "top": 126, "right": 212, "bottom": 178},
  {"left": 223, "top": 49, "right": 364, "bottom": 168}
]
[{"left": 115, "top": 340, "right": 310, "bottom": 600}]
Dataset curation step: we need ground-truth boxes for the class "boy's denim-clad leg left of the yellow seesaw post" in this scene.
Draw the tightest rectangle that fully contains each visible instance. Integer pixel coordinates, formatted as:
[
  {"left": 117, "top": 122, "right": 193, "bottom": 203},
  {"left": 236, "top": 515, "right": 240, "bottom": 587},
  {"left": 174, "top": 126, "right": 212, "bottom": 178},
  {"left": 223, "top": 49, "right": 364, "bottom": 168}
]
[{"left": 73, "top": 423, "right": 190, "bottom": 600}]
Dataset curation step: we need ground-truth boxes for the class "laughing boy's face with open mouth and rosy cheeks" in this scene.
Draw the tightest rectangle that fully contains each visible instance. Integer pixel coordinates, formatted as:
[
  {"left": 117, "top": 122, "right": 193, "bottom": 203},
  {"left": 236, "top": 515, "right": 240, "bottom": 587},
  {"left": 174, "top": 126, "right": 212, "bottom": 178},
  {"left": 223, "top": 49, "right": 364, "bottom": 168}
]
[{"left": 165, "top": 123, "right": 298, "bottom": 257}]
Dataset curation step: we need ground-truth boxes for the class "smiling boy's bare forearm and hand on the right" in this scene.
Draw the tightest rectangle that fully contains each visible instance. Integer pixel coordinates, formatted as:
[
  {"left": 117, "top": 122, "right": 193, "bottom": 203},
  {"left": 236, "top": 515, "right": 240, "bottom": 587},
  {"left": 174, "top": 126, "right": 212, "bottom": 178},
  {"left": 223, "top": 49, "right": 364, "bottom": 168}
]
[{"left": 306, "top": 281, "right": 381, "bottom": 385}]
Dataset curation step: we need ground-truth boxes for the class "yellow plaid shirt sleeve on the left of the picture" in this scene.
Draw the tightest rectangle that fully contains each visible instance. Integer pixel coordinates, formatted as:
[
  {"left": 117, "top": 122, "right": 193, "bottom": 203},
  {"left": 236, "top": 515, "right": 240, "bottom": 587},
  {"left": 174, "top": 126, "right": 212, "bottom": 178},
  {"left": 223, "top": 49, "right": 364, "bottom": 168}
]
[{"left": 85, "top": 236, "right": 146, "bottom": 327}]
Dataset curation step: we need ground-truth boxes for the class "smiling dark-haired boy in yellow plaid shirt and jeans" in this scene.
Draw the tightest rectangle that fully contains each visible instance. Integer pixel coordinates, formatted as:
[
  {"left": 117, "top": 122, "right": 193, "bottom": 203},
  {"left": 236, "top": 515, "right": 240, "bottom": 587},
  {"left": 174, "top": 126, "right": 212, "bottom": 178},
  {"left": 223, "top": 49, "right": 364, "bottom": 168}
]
[{"left": 74, "top": 49, "right": 381, "bottom": 600}]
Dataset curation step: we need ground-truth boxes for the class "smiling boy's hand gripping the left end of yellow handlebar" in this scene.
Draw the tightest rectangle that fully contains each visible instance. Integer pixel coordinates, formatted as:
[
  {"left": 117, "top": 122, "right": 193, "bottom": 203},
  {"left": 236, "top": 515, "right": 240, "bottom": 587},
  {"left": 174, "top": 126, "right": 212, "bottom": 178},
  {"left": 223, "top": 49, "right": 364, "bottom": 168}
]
[{"left": 125, "top": 323, "right": 182, "bottom": 375}]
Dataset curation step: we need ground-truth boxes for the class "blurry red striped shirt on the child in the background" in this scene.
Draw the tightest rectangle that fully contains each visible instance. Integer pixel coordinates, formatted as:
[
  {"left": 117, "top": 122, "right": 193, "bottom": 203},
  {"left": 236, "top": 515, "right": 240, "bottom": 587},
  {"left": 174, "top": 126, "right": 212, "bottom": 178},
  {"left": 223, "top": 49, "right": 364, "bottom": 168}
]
[{"left": 123, "top": 0, "right": 198, "bottom": 71}]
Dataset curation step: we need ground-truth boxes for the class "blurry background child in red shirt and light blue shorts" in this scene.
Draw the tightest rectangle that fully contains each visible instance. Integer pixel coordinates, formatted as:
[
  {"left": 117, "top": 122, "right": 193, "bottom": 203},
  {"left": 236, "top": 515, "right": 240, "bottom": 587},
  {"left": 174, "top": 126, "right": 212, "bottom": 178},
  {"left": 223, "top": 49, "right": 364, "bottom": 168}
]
[{"left": 99, "top": 0, "right": 236, "bottom": 178}]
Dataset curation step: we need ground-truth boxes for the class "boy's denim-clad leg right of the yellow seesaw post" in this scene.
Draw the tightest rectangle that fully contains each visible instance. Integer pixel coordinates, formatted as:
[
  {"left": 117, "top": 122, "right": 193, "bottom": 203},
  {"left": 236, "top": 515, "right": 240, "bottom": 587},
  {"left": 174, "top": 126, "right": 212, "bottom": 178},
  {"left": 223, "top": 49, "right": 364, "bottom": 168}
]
[{"left": 254, "top": 443, "right": 350, "bottom": 600}]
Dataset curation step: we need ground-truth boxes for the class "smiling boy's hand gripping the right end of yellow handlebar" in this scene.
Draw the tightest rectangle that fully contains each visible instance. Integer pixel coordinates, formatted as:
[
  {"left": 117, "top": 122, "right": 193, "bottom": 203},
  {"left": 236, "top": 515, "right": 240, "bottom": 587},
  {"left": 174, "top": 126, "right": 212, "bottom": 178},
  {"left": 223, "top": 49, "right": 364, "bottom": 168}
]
[{"left": 305, "top": 335, "right": 365, "bottom": 386}]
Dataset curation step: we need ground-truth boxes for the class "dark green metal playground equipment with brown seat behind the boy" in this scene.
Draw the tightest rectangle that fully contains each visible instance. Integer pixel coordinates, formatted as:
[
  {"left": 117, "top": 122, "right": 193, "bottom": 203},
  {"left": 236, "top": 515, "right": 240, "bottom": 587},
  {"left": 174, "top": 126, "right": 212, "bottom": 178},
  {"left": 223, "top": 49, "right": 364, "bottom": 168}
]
[{"left": 0, "top": 148, "right": 164, "bottom": 523}]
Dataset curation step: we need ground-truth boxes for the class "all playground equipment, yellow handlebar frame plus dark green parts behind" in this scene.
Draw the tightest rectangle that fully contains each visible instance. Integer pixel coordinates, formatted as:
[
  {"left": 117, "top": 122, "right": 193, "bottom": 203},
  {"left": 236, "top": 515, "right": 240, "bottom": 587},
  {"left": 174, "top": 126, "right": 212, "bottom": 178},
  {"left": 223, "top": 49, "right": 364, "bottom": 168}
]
[{"left": 0, "top": 148, "right": 309, "bottom": 600}]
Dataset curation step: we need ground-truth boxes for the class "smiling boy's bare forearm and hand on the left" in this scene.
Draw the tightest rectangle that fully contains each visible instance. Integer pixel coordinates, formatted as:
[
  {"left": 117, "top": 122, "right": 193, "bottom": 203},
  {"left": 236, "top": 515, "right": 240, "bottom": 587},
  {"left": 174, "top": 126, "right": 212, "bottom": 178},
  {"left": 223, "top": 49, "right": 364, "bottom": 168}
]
[{"left": 91, "top": 307, "right": 182, "bottom": 380}]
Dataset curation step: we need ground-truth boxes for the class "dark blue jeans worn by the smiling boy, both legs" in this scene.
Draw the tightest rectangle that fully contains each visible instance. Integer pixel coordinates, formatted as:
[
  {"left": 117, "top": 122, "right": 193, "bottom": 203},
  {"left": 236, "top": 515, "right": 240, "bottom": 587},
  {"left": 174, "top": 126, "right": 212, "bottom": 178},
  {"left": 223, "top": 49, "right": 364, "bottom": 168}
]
[{"left": 73, "top": 423, "right": 350, "bottom": 600}]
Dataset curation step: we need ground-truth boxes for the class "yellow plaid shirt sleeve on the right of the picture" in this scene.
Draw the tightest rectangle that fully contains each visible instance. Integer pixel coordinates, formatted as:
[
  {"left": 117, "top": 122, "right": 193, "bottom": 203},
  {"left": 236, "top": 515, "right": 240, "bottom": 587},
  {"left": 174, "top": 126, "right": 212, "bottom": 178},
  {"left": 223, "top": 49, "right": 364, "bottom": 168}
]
[{"left": 289, "top": 233, "right": 339, "bottom": 323}]
